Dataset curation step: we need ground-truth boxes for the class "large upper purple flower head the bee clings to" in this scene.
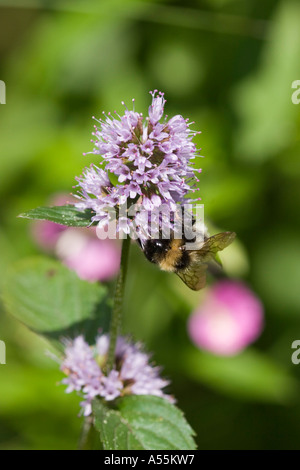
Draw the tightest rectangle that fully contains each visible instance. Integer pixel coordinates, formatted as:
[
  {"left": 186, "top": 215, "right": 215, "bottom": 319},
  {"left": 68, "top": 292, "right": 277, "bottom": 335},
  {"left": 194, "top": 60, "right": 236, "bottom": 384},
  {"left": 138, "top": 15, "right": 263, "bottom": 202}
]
[{"left": 76, "top": 90, "right": 200, "bottom": 238}]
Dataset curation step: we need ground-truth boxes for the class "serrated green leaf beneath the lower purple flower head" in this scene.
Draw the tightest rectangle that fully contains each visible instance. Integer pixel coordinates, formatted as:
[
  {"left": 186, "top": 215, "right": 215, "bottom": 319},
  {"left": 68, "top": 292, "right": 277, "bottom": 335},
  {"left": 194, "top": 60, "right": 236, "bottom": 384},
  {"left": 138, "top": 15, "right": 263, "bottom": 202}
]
[{"left": 93, "top": 395, "right": 196, "bottom": 450}]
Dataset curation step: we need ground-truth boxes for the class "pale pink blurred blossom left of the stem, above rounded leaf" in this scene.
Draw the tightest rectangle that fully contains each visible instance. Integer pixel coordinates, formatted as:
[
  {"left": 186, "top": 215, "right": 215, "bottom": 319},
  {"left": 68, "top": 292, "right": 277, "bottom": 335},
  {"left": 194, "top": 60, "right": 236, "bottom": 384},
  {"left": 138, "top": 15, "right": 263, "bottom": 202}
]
[{"left": 56, "top": 228, "right": 121, "bottom": 282}]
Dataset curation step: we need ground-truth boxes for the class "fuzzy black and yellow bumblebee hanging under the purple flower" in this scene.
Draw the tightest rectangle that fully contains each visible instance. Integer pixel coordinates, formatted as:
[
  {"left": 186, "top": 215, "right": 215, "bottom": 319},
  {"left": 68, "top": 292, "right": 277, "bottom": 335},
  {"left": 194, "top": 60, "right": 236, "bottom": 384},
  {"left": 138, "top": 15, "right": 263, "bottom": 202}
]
[{"left": 139, "top": 232, "right": 236, "bottom": 290}]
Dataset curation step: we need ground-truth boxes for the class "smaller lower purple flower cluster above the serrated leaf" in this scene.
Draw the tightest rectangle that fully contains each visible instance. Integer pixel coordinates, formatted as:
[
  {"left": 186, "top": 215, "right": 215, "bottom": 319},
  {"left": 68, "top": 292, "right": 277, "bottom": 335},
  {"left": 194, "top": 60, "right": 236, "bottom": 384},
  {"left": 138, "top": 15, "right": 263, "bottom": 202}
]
[{"left": 61, "top": 335, "right": 174, "bottom": 416}]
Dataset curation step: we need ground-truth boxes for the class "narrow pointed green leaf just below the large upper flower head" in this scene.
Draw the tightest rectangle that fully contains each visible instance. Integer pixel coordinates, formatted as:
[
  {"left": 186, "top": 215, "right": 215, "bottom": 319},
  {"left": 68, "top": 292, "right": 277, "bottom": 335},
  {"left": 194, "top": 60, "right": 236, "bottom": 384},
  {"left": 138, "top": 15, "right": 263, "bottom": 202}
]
[{"left": 19, "top": 204, "right": 94, "bottom": 227}]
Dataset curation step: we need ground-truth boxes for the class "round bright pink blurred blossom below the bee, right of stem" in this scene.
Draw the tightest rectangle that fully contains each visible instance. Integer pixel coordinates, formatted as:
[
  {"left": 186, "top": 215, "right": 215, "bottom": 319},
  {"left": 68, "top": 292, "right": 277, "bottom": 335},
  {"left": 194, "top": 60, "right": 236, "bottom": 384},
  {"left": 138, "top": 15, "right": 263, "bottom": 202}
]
[{"left": 188, "top": 280, "right": 263, "bottom": 356}]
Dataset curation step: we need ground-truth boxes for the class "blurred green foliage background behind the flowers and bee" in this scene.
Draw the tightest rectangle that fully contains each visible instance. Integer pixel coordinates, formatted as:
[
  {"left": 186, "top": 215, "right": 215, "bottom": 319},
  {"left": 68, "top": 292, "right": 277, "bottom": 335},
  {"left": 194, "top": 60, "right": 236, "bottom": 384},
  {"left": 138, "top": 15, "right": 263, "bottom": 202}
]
[{"left": 0, "top": 0, "right": 300, "bottom": 449}]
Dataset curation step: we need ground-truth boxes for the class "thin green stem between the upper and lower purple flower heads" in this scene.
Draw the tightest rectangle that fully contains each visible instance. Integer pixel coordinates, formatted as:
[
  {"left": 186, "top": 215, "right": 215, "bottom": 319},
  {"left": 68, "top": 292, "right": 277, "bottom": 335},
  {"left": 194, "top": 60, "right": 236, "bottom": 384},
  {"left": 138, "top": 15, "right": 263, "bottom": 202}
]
[{"left": 106, "top": 237, "right": 130, "bottom": 372}]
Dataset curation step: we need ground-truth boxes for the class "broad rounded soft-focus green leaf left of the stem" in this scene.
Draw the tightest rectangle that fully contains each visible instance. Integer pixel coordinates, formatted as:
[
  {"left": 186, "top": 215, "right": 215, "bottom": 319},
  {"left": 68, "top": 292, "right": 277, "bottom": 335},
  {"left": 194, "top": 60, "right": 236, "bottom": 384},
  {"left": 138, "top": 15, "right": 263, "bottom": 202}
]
[{"left": 3, "top": 257, "right": 109, "bottom": 348}]
